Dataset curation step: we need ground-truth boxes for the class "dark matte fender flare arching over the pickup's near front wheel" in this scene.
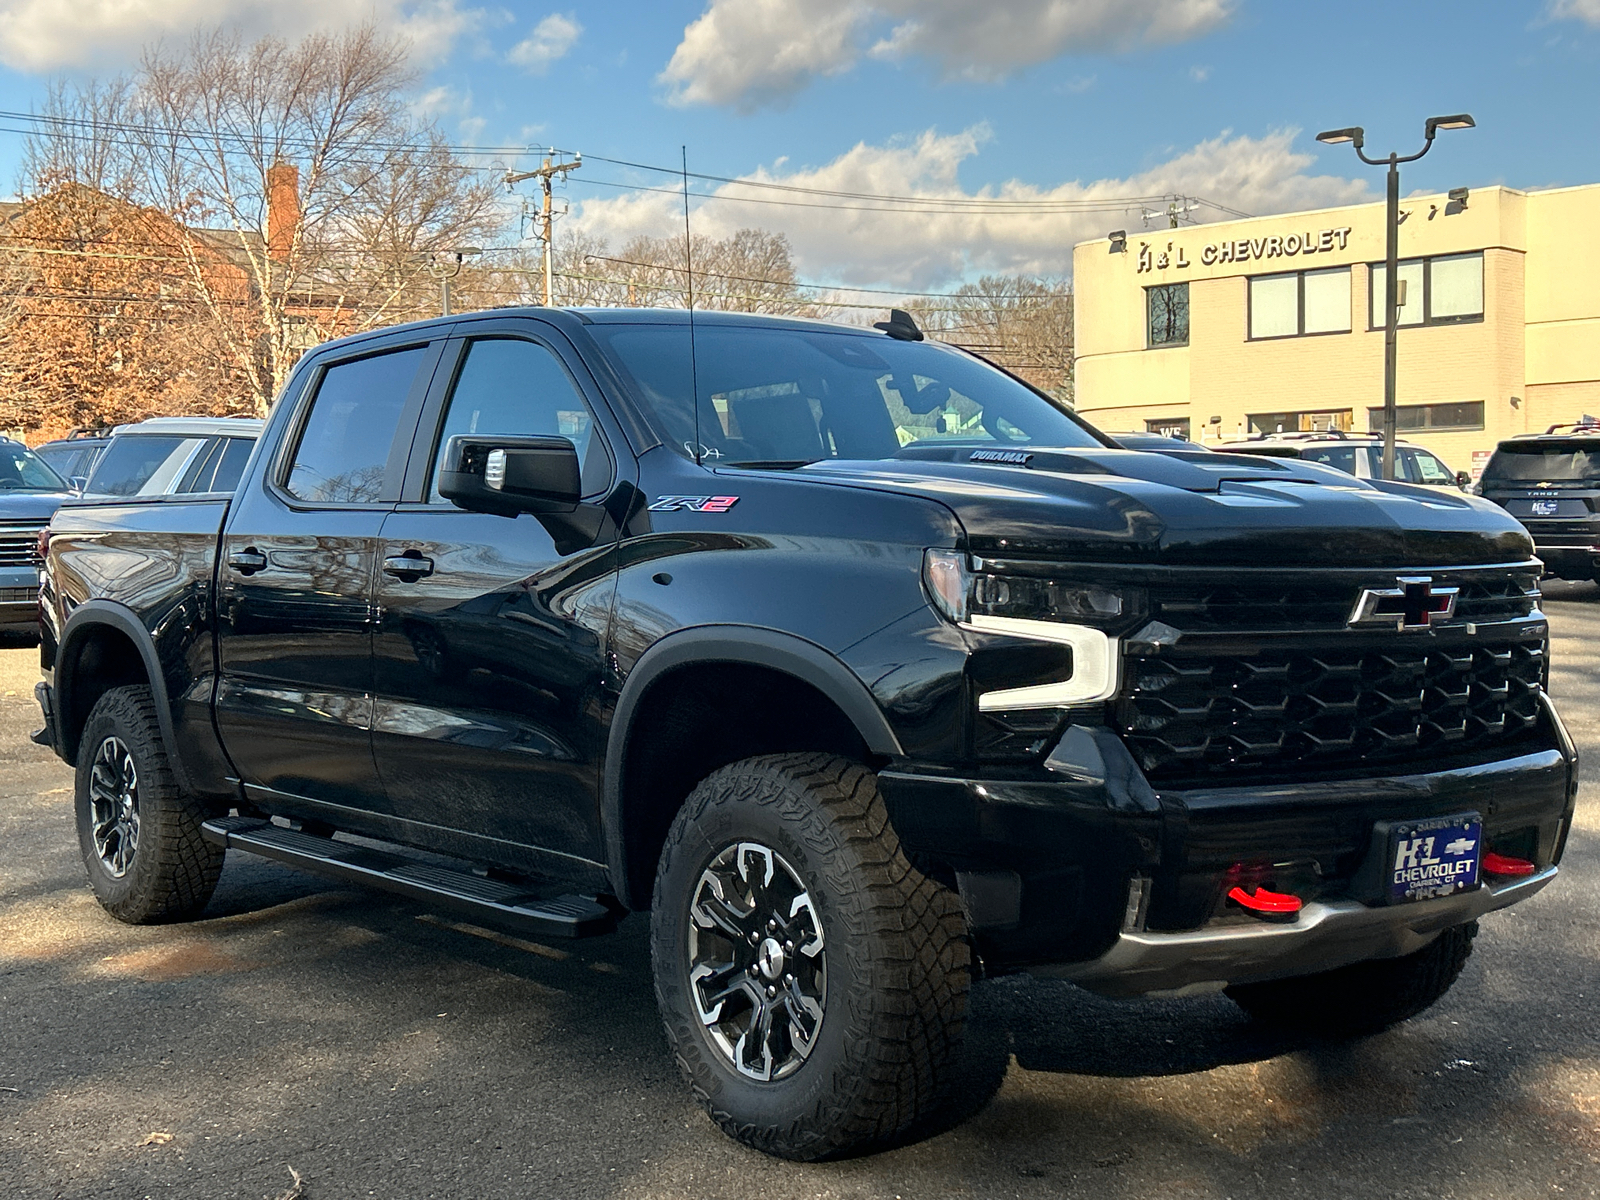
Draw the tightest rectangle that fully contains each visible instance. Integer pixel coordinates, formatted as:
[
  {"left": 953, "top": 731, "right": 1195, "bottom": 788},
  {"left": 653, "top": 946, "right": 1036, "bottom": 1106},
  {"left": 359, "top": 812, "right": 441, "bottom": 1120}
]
[{"left": 600, "top": 624, "right": 906, "bottom": 909}]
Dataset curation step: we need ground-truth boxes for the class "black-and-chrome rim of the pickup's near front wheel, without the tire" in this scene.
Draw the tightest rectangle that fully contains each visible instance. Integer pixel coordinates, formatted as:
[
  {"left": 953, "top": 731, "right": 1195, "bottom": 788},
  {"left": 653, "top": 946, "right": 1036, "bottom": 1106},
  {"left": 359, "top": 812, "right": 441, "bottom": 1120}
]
[{"left": 688, "top": 842, "right": 827, "bottom": 1080}]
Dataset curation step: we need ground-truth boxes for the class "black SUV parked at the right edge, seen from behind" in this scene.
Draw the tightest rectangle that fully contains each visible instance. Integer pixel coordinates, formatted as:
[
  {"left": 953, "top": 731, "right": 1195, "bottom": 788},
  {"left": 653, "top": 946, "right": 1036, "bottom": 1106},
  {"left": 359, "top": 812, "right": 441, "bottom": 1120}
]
[{"left": 1478, "top": 424, "right": 1600, "bottom": 579}]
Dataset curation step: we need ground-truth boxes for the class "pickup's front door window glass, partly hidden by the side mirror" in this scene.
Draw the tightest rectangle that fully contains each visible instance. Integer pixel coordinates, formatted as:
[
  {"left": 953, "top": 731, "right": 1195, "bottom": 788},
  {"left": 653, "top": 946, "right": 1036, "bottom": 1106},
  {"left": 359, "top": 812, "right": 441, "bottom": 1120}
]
[{"left": 429, "top": 338, "right": 611, "bottom": 501}]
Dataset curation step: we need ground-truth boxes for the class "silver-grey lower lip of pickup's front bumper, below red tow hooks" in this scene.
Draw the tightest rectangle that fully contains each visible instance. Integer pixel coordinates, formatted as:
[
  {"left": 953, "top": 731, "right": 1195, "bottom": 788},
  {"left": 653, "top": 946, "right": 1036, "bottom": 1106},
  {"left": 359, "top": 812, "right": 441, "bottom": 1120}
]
[{"left": 1030, "top": 866, "right": 1557, "bottom": 997}]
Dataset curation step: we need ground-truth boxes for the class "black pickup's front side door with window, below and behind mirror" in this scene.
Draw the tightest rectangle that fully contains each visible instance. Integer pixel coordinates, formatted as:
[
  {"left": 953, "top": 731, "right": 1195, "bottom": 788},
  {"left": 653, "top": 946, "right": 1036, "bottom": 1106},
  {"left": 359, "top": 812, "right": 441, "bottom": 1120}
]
[{"left": 373, "top": 329, "right": 616, "bottom": 870}]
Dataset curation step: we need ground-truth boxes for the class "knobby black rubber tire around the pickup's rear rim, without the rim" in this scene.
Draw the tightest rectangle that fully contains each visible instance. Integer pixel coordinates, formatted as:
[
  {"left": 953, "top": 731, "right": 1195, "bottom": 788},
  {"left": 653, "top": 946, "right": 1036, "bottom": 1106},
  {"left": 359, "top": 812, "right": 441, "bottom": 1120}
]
[{"left": 78, "top": 685, "right": 226, "bottom": 925}]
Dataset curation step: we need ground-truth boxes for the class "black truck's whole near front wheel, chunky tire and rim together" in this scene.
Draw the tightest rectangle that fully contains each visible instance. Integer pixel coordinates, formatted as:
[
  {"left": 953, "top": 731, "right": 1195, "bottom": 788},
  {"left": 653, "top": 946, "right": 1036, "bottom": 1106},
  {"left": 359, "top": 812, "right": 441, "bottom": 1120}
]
[{"left": 651, "top": 754, "right": 971, "bottom": 1160}]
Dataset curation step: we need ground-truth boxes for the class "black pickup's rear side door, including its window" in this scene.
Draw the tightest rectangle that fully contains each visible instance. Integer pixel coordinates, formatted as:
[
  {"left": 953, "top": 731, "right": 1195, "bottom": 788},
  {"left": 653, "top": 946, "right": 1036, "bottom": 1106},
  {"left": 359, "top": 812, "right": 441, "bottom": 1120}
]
[{"left": 216, "top": 339, "right": 443, "bottom": 811}]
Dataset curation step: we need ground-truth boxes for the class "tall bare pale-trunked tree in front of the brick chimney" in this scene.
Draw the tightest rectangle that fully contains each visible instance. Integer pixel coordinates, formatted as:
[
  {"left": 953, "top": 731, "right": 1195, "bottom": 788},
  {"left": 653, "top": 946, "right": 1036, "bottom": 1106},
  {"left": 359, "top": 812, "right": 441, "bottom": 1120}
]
[{"left": 26, "top": 24, "right": 506, "bottom": 411}]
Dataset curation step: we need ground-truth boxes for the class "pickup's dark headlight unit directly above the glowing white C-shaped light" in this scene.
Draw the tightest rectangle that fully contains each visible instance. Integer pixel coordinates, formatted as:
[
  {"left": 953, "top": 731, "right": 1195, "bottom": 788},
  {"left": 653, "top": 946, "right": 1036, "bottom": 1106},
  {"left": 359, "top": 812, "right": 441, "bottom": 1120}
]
[{"left": 922, "top": 550, "right": 1146, "bottom": 629}]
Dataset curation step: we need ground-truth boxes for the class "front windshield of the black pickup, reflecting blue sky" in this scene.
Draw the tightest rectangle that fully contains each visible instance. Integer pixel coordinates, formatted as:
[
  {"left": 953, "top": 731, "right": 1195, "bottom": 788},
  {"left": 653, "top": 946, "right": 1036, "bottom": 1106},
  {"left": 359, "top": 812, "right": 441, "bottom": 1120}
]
[{"left": 589, "top": 325, "right": 1102, "bottom": 466}]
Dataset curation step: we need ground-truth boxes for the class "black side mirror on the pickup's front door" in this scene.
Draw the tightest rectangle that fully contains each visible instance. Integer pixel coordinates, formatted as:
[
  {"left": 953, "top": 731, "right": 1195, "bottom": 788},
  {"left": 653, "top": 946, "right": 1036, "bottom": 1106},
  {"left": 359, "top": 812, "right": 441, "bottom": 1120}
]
[{"left": 438, "top": 434, "right": 582, "bottom": 517}]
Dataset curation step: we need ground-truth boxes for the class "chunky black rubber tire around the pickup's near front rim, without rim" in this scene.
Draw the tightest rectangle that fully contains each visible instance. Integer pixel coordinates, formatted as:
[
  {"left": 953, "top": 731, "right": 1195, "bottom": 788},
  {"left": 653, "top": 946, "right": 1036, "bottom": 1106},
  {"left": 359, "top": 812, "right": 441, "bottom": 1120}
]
[{"left": 654, "top": 754, "right": 971, "bottom": 1160}]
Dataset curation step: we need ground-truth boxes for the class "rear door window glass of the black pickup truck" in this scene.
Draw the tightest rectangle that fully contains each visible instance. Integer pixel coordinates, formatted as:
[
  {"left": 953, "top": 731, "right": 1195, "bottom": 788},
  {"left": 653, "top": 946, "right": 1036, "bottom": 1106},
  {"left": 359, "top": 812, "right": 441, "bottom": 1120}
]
[{"left": 283, "top": 346, "right": 427, "bottom": 504}]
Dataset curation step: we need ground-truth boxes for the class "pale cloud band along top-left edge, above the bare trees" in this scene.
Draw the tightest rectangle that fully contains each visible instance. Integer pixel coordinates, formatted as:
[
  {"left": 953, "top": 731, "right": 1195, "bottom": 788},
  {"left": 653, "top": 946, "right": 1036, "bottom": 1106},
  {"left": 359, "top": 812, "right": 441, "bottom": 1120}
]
[{"left": 0, "top": 0, "right": 490, "bottom": 72}]
